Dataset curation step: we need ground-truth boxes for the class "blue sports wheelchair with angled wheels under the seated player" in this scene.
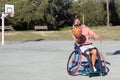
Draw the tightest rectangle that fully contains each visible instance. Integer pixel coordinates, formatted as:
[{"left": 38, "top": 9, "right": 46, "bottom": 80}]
[{"left": 67, "top": 45, "right": 110, "bottom": 77}]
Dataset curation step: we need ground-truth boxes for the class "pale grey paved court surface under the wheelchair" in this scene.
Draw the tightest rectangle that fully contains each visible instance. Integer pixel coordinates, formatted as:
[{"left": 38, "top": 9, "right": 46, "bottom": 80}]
[{"left": 0, "top": 40, "right": 120, "bottom": 80}]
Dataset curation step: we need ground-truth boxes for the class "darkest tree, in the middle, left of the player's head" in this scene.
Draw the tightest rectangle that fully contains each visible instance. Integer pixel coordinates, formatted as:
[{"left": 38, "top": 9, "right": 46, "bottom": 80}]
[{"left": 46, "top": 0, "right": 72, "bottom": 29}]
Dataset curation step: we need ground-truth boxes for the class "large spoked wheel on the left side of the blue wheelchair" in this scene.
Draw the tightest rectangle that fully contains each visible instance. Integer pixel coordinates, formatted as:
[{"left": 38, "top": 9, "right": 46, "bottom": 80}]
[{"left": 67, "top": 50, "right": 82, "bottom": 76}]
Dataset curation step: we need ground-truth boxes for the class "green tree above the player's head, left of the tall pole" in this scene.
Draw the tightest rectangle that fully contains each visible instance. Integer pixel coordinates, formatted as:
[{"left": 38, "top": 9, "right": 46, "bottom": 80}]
[{"left": 70, "top": 0, "right": 106, "bottom": 25}]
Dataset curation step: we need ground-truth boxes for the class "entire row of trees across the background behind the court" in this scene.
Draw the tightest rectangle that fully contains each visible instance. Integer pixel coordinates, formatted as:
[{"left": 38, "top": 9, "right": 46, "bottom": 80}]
[{"left": 0, "top": 0, "right": 120, "bottom": 30}]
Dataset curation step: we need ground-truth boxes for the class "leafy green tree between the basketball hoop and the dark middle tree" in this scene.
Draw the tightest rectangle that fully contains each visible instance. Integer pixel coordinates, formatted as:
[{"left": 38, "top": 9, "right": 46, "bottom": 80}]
[{"left": 7, "top": 0, "right": 48, "bottom": 30}]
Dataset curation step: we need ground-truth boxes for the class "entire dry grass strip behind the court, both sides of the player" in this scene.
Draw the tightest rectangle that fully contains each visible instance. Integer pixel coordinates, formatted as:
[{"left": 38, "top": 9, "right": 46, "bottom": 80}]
[{"left": 0, "top": 26, "right": 120, "bottom": 41}]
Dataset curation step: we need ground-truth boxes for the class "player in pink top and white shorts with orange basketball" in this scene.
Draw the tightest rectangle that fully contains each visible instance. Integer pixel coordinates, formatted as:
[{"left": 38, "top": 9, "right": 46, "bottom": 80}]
[{"left": 72, "top": 19, "right": 102, "bottom": 72}]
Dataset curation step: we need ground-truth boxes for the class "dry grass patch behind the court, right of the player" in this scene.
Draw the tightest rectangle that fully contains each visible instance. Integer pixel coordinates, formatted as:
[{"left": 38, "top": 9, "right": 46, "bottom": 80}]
[{"left": 92, "top": 26, "right": 120, "bottom": 40}]
